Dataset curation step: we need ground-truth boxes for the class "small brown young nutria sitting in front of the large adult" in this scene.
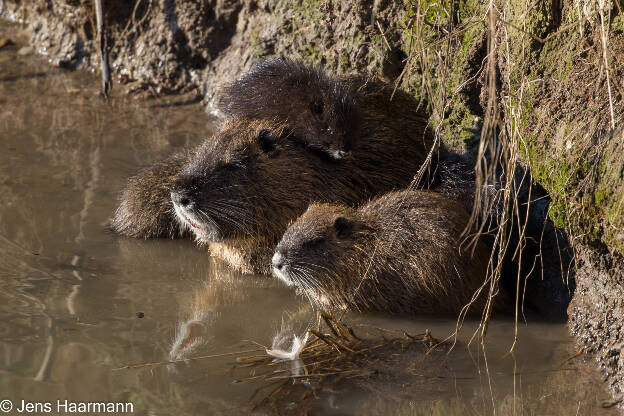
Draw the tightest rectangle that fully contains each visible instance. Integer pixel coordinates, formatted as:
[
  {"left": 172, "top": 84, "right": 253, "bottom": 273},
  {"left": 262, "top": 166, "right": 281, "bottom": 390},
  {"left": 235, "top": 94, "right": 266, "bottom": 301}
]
[{"left": 273, "top": 191, "right": 508, "bottom": 314}]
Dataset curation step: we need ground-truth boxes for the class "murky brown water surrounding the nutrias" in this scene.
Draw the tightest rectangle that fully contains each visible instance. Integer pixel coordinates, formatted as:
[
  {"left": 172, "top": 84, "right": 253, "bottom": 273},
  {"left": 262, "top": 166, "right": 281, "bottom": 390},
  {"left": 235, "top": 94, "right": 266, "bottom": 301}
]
[{"left": 0, "top": 33, "right": 613, "bottom": 415}]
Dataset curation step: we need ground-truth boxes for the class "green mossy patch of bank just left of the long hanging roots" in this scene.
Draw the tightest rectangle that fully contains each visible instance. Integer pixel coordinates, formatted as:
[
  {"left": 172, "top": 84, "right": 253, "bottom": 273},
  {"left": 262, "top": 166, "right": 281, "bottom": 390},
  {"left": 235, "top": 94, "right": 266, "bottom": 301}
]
[{"left": 398, "top": 0, "right": 485, "bottom": 151}]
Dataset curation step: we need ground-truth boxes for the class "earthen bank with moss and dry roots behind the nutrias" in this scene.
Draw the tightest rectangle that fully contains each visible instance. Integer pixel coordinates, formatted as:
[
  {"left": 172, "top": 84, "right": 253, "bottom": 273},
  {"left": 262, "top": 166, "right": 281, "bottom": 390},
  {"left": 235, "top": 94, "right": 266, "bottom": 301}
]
[{"left": 0, "top": 0, "right": 624, "bottom": 406}]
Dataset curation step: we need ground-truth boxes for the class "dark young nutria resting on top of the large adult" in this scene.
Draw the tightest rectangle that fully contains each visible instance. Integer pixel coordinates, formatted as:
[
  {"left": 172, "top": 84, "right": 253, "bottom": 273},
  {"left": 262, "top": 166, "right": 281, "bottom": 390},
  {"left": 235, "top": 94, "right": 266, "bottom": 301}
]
[{"left": 217, "top": 59, "right": 358, "bottom": 159}]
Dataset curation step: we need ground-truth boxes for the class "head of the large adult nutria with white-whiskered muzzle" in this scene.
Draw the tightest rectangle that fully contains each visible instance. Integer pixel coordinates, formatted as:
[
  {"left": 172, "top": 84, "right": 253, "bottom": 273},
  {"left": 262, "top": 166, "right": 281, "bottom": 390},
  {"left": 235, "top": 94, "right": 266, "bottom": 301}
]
[{"left": 171, "top": 119, "right": 336, "bottom": 249}]
